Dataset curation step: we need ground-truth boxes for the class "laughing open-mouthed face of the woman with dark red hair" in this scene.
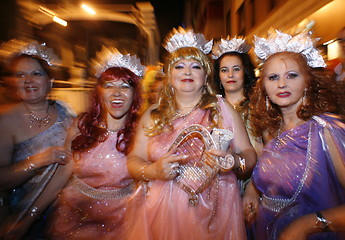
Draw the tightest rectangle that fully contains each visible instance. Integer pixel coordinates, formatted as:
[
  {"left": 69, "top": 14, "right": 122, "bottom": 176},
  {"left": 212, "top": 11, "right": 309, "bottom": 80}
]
[{"left": 101, "top": 79, "right": 134, "bottom": 119}]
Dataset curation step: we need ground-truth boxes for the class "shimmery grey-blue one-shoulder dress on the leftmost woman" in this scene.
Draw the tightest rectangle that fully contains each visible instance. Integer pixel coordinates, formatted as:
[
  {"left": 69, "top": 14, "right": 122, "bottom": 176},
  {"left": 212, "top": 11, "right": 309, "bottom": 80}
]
[{"left": 5, "top": 101, "right": 74, "bottom": 235}]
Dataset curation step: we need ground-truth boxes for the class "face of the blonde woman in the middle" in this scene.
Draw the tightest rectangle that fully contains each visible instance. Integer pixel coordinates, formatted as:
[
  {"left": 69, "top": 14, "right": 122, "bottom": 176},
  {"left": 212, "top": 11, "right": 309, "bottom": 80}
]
[{"left": 170, "top": 59, "right": 207, "bottom": 94}]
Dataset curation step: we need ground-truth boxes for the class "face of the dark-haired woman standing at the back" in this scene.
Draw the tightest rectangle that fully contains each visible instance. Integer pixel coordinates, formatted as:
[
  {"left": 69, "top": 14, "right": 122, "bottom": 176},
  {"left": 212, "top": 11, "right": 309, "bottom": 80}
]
[{"left": 219, "top": 56, "right": 244, "bottom": 93}]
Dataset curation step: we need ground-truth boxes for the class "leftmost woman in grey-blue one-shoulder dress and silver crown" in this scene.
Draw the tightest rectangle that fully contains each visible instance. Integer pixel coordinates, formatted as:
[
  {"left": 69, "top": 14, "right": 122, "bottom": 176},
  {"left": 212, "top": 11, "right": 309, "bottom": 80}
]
[{"left": 0, "top": 42, "right": 73, "bottom": 238}]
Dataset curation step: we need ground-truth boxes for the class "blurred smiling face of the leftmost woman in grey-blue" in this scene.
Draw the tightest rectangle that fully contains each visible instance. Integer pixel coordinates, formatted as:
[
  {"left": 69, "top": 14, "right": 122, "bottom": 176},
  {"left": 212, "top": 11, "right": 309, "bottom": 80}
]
[{"left": 14, "top": 57, "right": 51, "bottom": 102}]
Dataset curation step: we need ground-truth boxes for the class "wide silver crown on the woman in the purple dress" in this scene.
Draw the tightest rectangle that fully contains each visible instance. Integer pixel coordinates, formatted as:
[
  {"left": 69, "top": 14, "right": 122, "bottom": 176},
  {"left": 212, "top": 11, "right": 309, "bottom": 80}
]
[{"left": 254, "top": 30, "right": 327, "bottom": 68}]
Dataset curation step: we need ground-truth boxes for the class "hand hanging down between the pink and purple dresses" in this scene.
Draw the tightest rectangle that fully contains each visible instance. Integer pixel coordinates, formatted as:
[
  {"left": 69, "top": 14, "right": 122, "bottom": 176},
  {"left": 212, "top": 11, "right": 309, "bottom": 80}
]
[{"left": 242, "top": 182, "right": 260, "bottom": 223}]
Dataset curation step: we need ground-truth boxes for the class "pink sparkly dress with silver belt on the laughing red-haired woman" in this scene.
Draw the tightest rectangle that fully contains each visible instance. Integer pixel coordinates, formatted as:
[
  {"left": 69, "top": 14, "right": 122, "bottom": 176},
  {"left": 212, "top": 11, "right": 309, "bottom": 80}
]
[{"left": 50, "top": 133, "right": 134, "bottom": 240}]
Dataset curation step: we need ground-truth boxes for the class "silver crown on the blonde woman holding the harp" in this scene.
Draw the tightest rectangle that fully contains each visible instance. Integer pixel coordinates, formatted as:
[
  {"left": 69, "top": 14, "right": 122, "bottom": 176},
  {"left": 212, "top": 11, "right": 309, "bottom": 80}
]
[{"left": 164, "top": 27, "right": 213, "bottom": 54}]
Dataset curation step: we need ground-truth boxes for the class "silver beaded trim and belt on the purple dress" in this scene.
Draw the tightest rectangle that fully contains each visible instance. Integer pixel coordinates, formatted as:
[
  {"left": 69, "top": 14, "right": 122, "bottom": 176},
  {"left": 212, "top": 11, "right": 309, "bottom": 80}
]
[{"left": 261, "top": 125, "right": 311, "bottom": 212}]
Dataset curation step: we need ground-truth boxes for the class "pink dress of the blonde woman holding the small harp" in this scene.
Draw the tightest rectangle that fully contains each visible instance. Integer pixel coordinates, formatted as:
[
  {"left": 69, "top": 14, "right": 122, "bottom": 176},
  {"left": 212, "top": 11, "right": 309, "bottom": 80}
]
[{"left": 128, "top": 99, "right": 246, "bottom": 240}]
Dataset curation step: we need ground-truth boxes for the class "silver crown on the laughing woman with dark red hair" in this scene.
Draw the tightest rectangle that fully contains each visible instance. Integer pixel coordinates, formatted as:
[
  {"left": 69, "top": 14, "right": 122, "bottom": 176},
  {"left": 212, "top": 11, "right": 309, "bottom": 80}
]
[{"left": 93, "top": 46, "right": 145, "bottom": 78}]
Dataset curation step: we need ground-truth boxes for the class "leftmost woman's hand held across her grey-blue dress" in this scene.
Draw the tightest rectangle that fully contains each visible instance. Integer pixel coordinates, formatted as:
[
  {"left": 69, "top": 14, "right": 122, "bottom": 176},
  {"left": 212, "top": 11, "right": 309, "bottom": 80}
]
[{"left": 29, "top": 146, "right": 72, "bottom": 169}]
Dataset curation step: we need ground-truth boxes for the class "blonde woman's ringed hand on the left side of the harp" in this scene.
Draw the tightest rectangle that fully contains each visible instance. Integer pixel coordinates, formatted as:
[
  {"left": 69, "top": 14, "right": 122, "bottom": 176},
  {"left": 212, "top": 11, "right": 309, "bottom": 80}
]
[{"left": 149, "top": 149, "right": 188, "bottom": 180}]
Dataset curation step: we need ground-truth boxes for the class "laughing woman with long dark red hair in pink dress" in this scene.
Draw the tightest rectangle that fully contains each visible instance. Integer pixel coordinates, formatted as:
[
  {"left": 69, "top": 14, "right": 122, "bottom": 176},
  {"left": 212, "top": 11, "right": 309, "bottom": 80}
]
[{"left": 50, "top": 48, "right": 144, "bottom": 239}]
